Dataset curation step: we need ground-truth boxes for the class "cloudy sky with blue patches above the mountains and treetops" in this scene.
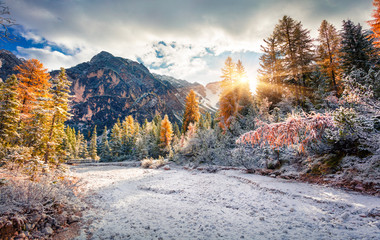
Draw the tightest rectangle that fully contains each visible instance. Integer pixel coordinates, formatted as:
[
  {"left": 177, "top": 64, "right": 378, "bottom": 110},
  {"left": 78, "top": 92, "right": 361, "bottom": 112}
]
[{"left": 0, "top": 0, "right": 373, "bottom": 87}]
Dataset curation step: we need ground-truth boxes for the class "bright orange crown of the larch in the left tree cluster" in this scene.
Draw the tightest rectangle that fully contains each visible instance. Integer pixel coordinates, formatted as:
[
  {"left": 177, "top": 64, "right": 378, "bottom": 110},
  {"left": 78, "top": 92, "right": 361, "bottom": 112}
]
[{"left": 15, "top": 59, "right": 50, "bottom": 115}]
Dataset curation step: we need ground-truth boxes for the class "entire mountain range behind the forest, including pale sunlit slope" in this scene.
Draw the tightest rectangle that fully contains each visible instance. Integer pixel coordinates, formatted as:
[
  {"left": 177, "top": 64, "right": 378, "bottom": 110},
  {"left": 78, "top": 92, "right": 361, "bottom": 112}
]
[{"left": 0, "top": 50, "right": 220, "bottom": 131}]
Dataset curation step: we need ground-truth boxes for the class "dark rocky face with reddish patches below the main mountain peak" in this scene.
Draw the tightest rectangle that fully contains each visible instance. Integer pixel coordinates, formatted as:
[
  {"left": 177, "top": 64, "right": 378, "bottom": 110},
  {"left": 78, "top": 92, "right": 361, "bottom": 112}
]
[{"left": 51, "top": 52, "right": 187, "bottom": 129}]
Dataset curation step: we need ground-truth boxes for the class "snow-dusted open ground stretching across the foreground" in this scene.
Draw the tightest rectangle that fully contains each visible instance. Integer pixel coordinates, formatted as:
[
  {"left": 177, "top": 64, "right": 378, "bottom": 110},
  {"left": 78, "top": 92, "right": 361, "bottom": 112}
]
[{"left": 72, "top": 163, "right": 380, "bottom": 240}]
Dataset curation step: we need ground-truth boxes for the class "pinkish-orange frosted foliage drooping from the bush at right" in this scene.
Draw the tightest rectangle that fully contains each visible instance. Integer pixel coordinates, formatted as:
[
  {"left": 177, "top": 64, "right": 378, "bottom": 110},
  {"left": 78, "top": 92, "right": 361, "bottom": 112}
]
[{"left": 237, "top": 113, "right": 334, "bottom": 152}]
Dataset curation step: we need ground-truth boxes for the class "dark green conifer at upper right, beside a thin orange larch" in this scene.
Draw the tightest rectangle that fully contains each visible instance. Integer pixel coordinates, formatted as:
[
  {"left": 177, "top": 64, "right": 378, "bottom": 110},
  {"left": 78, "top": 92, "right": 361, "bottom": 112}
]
[{"left": 340, "top": 20, "right": 378, "bottom": 76}]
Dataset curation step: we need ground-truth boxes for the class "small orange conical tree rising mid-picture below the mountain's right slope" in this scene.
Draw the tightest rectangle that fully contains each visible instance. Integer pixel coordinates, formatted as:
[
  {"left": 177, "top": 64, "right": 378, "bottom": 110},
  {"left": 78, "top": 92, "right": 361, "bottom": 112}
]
[{"left": 182, "top": 90, "right": 200, "bottom": 133}]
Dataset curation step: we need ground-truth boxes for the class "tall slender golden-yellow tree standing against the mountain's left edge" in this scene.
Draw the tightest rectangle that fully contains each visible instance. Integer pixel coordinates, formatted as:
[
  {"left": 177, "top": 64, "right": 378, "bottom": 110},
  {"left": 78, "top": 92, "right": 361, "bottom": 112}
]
[{"left": 44, "top": 68, "right": 71, "bottom": 163}]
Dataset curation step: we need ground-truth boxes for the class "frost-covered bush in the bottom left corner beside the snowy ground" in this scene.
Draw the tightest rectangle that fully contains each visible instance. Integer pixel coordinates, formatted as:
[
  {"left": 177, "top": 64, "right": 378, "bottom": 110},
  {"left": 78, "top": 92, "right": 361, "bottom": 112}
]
[{"left": 0, "top": 169, "right": 82, "bottom": 239}]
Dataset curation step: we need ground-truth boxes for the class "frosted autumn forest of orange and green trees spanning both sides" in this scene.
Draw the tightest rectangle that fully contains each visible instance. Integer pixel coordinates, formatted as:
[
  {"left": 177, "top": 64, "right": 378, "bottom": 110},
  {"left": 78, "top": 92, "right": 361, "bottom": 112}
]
[{"left": 0, "top": 0, "right": 380, "bottom": 237}]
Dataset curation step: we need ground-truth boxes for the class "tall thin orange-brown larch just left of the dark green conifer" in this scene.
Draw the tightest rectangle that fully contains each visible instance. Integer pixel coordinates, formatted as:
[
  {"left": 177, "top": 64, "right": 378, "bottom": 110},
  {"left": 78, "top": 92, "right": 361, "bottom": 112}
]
[{"left": 317, "top": 20, "right": 341, "bottom": 96}]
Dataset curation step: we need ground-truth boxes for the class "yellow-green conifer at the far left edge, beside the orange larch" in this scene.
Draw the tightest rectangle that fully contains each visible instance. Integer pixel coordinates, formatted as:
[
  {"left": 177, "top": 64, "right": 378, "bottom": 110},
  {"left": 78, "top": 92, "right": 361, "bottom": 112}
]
[{"left": 0, "top": 75, "right": 20, "bottom": 145}]
